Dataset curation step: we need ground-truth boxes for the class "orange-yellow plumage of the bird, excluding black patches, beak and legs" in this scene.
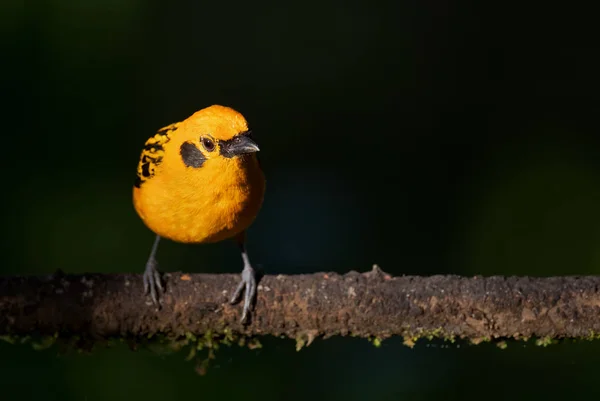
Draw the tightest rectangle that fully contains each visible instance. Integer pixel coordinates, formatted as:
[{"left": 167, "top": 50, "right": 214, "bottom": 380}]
[{"left": 133, "top": 105, "right": 265, "bottom": 243}]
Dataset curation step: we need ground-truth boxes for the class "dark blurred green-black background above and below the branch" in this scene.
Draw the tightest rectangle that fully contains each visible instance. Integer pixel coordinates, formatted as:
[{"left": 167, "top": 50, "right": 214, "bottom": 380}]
[{"left": 0, "top": 0, "right": 600, "bottom": 401}]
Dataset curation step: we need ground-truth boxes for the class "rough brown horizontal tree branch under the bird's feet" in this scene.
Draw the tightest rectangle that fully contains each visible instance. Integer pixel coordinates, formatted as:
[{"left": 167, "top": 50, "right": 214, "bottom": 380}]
[{"left": 0, "top": 266, "right": 600, "bottom": 345}]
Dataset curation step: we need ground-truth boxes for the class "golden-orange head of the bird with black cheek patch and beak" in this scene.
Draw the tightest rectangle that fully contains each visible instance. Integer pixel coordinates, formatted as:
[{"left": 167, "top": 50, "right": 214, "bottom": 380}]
[{"left": 177, "top": 105, "right": 259, "bottom": 167}]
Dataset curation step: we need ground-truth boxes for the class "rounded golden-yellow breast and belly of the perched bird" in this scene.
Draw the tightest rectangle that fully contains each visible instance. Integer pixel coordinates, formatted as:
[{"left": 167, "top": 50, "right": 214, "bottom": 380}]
[{"left": 133, "top": 155, "right": 265, "bottom": 243}]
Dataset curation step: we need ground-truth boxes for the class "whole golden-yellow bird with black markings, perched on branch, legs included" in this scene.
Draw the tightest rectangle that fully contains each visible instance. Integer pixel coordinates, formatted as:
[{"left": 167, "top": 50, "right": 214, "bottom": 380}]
[{"left": 133, "top": 105, "right": 265, "bottom": 322}]
